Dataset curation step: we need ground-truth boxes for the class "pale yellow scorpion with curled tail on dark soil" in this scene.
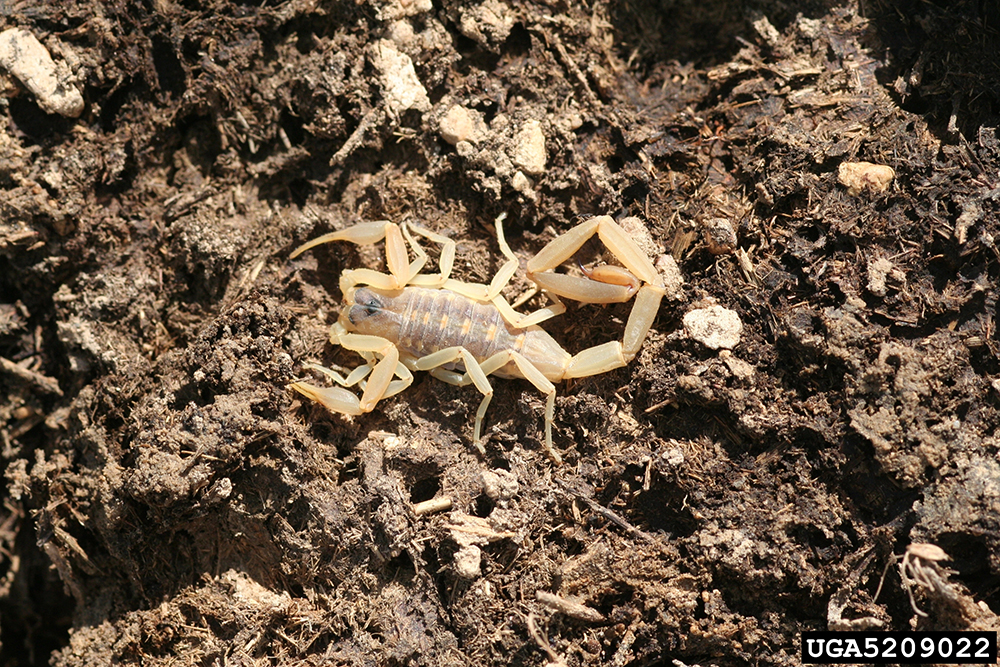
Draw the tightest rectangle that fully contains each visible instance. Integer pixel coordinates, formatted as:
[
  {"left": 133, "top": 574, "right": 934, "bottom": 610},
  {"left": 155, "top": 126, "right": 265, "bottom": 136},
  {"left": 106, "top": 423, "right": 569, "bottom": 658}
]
[{"left": 291, "top": 215, "right": 665, "bottom": 462}]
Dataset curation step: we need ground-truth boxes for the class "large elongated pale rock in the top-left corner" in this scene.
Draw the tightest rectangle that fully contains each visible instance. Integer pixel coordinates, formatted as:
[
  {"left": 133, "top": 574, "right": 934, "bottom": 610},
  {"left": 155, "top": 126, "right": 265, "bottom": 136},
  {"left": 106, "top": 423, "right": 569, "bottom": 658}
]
[{"left": 0, "top": 28, "right": 83, "bottom": 118}]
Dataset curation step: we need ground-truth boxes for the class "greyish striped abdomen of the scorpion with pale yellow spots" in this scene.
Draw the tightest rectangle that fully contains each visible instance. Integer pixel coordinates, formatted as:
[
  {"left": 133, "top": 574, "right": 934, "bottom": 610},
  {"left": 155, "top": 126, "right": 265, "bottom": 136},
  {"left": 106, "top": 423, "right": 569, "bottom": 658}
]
[{"left": 397, "top": 287, "right": 524, "bottom": 361}]
